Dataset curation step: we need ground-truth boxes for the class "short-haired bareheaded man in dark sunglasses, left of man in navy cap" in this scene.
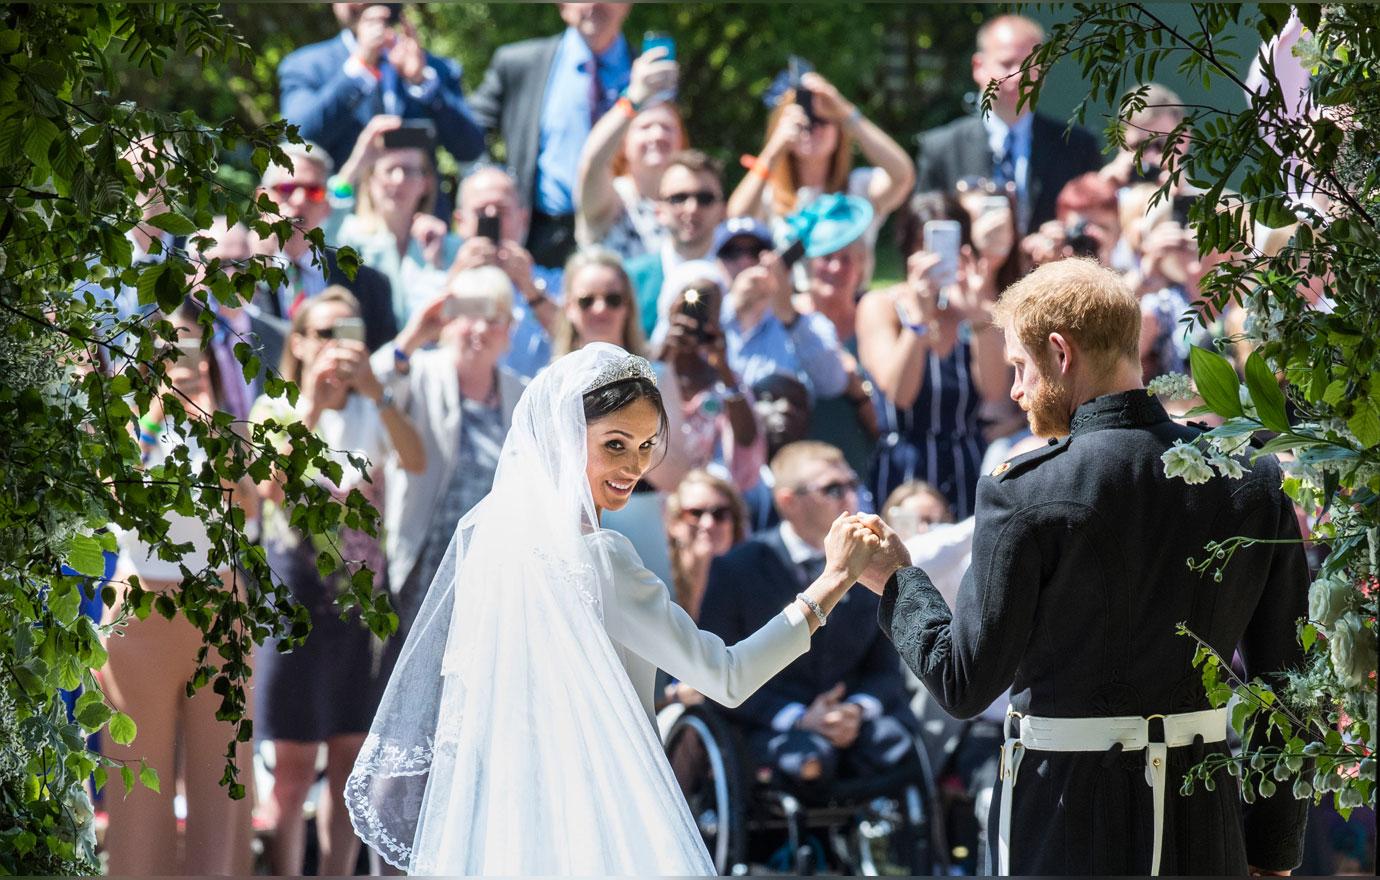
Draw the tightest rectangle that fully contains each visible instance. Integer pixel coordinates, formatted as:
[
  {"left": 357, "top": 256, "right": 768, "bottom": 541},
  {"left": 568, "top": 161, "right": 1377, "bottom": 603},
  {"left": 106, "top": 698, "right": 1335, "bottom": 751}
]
[{"left": 627, "top": 150, "right": 726, "bottom": 339}]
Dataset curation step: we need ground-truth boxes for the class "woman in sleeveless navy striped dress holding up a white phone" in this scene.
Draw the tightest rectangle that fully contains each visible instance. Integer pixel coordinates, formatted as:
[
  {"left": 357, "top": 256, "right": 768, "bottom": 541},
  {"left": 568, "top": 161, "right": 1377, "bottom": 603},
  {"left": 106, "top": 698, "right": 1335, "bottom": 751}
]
[{"left": 857, "top": 193, "right": 1009, "bottom": 519}]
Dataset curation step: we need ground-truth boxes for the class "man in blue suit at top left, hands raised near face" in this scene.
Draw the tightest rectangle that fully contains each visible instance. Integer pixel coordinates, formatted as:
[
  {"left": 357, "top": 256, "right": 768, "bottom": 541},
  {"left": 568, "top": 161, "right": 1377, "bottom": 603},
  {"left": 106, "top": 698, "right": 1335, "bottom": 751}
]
[{"left": 277, "top": 3, "right": 484, "bottom": 173}]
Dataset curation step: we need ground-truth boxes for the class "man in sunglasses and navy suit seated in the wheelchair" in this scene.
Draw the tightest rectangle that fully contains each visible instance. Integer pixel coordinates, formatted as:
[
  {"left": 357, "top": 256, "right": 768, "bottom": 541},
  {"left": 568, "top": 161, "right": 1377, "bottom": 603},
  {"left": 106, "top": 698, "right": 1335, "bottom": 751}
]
[{"left": 700, "top": 440, "right": 918, "bottom": 796}]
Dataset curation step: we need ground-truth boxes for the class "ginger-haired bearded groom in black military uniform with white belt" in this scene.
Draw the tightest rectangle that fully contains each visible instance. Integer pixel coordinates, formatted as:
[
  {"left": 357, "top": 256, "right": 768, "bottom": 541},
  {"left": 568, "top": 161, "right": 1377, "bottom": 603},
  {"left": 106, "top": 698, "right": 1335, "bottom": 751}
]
[{"left": 861, "top": 259, "right": 1308, "bottom": 874}]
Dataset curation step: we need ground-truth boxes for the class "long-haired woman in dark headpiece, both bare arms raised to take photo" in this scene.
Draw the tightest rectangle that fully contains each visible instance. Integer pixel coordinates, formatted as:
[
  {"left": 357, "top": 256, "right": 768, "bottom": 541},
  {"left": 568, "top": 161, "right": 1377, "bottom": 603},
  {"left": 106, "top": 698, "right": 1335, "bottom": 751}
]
[{"left": 729, "top": 72, "right": 915, "bottom": 288}]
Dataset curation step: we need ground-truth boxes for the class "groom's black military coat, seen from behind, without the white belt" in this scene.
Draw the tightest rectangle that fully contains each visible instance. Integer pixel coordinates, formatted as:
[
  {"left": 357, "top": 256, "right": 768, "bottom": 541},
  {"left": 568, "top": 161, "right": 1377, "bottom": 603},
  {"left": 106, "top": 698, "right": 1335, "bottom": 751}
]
[{"left": 879, "top": 390, "right": 1308, "bottom": 874}]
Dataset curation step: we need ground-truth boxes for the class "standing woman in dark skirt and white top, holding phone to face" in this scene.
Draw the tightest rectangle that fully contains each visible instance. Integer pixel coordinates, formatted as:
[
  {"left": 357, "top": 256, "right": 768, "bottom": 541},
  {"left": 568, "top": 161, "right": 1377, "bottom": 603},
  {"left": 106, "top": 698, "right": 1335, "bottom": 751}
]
[{"left": 251, "top": 287, "right": 426, "bottom": 874}]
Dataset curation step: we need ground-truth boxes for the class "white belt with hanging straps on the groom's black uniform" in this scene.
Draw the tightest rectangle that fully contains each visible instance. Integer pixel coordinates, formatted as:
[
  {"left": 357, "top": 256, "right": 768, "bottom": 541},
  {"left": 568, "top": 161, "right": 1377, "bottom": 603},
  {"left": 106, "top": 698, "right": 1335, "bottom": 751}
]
[{"left": 996, "top": 709, "right": 1227, "bottom": 877}]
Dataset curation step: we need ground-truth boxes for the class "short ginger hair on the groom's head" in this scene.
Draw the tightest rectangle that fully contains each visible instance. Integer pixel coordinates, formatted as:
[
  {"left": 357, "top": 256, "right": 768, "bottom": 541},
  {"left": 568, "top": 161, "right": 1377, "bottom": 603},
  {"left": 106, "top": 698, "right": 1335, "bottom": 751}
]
[{"left": 992, "top": 258, "right": 1140, "bottom": 368}]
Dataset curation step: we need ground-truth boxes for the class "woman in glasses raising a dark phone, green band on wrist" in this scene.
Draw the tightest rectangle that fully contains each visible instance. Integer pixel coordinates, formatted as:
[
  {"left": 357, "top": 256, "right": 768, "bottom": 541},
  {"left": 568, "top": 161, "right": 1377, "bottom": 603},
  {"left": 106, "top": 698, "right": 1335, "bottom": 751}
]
[{"left": 327, "top": 116, "right": 460, "bottom": 327}]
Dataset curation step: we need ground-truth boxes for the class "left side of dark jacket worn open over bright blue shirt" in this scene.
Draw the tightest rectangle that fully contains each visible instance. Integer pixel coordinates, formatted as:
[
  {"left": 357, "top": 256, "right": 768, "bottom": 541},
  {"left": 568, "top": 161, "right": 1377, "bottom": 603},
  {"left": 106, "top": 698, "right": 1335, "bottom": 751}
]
[{"left": 469, "top": 33, "right": 563, "bottom": 213}]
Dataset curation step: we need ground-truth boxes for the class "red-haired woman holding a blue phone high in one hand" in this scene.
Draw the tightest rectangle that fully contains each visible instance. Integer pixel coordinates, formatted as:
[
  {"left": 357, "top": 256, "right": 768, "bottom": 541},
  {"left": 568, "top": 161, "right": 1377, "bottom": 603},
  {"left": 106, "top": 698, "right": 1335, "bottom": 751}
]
[{"left": 575, "top": 33, "right": 690, "bottom": 259}]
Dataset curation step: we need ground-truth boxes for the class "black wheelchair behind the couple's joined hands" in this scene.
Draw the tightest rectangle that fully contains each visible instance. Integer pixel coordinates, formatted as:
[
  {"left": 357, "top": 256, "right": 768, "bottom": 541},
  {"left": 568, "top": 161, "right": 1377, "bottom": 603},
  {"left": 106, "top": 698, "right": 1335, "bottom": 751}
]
[{"left": 657, "top": 703, "right": 949, "bottom": 876}]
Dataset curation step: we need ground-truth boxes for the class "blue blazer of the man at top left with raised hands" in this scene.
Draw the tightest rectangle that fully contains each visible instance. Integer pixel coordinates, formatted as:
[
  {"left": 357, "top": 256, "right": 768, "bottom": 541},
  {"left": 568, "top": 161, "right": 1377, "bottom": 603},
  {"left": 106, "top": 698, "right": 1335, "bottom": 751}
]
[{"left": 277, "top": 34, "right": 484, "bottom": 167}]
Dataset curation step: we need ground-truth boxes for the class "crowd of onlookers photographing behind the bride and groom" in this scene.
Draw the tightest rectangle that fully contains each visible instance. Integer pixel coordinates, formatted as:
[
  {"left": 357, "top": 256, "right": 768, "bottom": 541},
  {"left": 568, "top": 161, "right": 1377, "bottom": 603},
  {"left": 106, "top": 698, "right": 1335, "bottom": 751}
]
[{"left": 89, "top": 3, "right": 1368, "bottom": 874}]
